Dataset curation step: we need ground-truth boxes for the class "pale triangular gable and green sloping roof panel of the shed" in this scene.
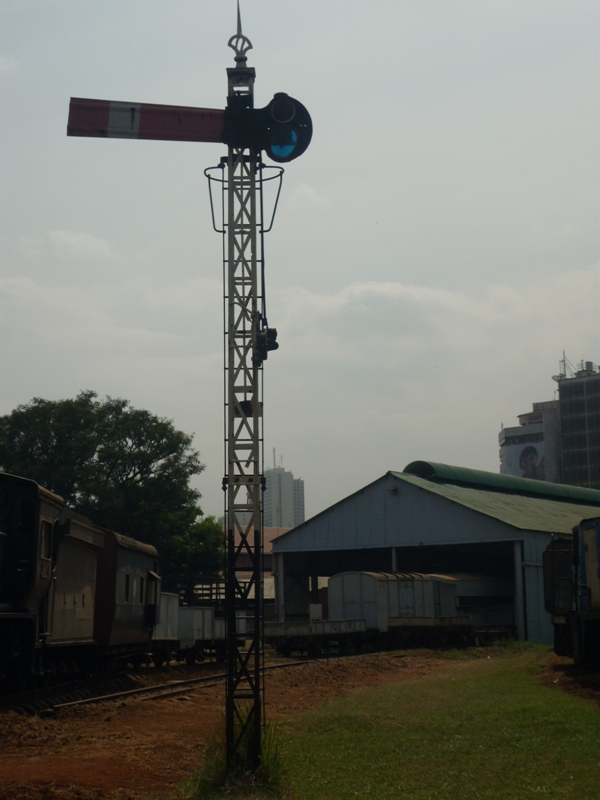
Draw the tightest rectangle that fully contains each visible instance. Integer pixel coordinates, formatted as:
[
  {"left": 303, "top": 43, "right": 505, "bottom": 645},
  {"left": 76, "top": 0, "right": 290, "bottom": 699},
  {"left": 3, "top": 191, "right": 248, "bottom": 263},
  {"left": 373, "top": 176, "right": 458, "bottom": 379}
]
[{"left": 273, "top": 473, "right": 594, "bottom": 552}]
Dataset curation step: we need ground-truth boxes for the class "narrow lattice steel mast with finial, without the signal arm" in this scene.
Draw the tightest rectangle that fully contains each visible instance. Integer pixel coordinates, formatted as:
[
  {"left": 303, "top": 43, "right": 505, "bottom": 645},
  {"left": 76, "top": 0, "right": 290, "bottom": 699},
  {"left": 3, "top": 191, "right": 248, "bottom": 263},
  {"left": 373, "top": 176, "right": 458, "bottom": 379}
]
[{"left": 223, "top": 14, "right": 263, "bottom": 766}]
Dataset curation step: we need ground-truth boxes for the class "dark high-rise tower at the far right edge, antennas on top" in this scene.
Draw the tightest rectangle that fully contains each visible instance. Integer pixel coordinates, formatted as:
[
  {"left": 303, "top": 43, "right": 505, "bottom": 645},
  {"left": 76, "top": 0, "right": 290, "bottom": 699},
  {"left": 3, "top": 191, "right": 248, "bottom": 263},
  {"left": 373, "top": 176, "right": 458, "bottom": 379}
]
[{"left": 555, "top": 359, "right": 600, "bottom": 489}]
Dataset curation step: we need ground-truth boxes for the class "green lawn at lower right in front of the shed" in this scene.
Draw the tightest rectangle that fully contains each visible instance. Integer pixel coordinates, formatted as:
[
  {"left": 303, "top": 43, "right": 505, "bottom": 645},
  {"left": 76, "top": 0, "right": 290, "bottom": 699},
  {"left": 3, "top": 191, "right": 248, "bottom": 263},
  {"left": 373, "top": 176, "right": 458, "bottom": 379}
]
[{"left": 176, "top": 648, "right": 600, "bottom": 800}]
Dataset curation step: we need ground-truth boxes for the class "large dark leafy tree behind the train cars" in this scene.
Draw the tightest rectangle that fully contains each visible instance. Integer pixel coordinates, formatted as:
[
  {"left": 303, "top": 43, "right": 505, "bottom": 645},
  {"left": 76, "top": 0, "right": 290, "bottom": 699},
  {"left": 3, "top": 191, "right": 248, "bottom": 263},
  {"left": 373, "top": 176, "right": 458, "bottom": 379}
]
[{"left": 0, "top": 391, "right": 223, "bottom": 581}]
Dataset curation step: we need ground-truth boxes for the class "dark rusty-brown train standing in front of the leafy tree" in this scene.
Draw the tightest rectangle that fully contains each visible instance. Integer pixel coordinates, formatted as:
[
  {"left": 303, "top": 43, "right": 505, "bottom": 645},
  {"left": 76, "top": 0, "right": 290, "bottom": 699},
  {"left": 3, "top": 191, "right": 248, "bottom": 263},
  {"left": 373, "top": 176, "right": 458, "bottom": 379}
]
[{"left": 0, "top": 473, "right": 160, "bottom": 690}]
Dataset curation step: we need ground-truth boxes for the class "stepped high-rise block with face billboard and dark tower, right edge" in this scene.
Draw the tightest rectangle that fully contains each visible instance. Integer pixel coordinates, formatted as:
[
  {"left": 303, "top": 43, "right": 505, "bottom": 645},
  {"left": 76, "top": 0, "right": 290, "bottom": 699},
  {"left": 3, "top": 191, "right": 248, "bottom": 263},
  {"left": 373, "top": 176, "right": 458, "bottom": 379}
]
[{"left": 498, "top": 356, "right": 600, "bottom": 489}]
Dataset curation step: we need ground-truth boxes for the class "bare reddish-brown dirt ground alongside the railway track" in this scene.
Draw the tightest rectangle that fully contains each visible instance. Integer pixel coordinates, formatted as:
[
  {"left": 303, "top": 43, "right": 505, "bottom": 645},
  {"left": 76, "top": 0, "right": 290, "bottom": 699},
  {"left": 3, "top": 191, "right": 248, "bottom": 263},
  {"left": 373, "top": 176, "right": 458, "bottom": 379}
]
[{"left": 0, "top": 651, "right": 600, "bottom": 800}]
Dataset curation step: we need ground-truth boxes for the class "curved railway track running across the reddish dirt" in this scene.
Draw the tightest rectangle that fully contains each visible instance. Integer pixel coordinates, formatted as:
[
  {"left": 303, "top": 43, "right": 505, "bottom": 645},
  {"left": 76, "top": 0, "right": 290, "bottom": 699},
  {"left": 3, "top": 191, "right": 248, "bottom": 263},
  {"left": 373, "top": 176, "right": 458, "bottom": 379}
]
[{"left": 0, "top": 659, "right": 307, "bottom": 716}]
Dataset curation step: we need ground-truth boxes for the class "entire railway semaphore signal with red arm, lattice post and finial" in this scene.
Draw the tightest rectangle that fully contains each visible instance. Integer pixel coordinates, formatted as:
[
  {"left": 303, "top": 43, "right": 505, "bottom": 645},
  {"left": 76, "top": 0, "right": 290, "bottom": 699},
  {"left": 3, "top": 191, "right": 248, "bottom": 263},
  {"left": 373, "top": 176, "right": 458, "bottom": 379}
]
[{"left": 67, "top": 4, "right": 312, "bottom": 768}]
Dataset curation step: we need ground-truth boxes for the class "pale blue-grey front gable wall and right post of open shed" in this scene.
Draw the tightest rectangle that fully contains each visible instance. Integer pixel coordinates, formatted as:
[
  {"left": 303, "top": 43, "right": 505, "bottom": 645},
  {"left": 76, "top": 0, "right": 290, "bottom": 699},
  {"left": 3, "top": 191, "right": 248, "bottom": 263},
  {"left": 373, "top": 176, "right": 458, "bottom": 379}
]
[{"left": 273, "top": 474, "right": 552, "bottom": 644}]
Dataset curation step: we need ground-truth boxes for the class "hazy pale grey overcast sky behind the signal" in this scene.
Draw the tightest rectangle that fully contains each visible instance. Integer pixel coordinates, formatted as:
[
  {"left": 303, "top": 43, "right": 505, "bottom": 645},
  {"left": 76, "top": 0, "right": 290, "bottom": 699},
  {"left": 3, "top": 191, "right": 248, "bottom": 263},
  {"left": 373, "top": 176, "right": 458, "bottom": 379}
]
[{"left": 0, "top": 0, "right": 600, "bottom": 515}]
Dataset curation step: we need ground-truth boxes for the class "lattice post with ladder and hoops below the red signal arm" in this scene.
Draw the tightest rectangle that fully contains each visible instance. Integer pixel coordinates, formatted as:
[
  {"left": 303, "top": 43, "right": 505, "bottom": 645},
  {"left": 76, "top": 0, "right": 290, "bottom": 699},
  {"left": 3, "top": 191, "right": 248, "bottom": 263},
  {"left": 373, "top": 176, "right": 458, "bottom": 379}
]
[{"left": 205, "top": 147, "right": 283, "bottom": 767}]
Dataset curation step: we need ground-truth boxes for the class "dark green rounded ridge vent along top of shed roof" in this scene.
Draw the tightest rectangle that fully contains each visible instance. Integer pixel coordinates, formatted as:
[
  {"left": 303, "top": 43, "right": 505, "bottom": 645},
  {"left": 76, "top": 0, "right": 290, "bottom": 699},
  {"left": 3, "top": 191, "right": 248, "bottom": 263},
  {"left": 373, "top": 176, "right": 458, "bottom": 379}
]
[{"left": 404, "top": 461, "right": 600, "bottom": 506}]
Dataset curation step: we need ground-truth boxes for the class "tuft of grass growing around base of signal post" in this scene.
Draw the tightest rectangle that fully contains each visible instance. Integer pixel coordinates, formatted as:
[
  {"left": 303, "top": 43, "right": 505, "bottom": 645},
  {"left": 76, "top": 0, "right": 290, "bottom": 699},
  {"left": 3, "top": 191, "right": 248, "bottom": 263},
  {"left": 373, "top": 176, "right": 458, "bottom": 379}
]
[{"left": 175, "top": 708, "right": 286, "bottom": 800}]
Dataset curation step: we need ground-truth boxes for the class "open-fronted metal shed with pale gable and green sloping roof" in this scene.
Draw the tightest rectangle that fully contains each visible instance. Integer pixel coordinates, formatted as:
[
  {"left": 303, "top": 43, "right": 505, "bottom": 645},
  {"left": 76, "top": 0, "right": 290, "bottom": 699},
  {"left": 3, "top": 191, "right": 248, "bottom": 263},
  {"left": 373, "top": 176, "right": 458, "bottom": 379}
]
[{"left": 273, "top": 462, "right": 600, "bottom": 642}]
